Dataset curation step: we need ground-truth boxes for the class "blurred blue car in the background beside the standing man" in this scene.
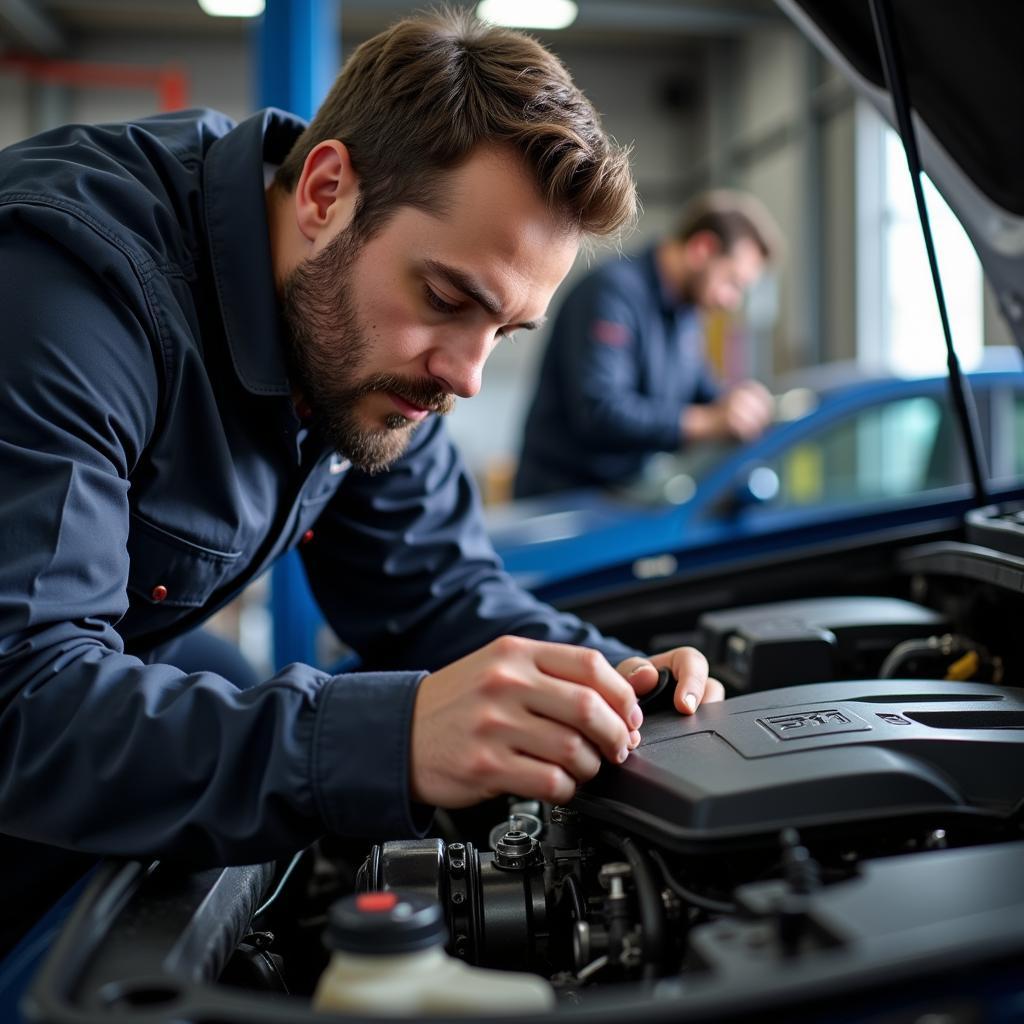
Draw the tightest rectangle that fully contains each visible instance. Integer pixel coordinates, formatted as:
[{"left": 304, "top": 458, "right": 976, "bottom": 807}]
[{"left": 488, "top": 346, "right": 1024, "bottom": 599}]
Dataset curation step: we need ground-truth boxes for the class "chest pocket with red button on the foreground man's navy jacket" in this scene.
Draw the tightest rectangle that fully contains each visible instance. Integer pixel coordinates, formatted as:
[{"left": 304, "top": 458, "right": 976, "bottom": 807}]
[{"left": 128, "top": 513, "right": 242, "bottom": 608}]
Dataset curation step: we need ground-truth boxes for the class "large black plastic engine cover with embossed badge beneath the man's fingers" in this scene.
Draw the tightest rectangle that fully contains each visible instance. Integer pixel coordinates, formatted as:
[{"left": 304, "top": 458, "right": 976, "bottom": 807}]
[{"left": 577, "top": 680, "right": 1024, "bottom": 852}]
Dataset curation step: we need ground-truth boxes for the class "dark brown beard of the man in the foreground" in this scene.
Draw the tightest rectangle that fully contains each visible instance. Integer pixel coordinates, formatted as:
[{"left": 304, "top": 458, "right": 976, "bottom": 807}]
[{"left": 281, "top": 227, "right": 455, "bottom": 473}]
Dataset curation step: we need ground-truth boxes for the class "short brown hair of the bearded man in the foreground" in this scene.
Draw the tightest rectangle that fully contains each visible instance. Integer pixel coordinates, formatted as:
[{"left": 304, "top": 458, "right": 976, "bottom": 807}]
[{"left": 275, "top": 9, "right": 637, "bottom": 237}]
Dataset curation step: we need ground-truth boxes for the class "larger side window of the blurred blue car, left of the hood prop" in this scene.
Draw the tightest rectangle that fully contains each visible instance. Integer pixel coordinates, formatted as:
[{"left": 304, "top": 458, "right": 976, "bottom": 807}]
[{"left": 766, "top": 395, "right": 966, "bottom": 508}]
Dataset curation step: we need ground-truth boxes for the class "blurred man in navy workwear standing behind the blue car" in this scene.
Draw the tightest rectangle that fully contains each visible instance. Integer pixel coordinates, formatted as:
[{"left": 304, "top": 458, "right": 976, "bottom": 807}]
[{"left": 513, "top": 189, "right": 779, "bottom": 498}]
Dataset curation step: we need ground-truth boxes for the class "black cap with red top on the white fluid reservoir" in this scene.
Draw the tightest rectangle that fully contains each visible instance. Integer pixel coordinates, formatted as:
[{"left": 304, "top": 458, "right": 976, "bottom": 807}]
[{"left": 324, "top": 889, "right": 447, "bottom": 954}]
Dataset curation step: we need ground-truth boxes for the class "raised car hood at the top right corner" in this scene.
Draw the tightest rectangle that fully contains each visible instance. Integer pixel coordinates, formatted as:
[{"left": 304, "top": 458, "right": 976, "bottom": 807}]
[{"left": 776, "top": 0, "right": 1024, "bottom": 350}]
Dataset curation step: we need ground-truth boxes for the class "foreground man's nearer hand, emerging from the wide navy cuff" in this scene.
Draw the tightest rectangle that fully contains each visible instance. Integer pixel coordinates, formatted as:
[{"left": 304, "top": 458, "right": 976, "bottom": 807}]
[{"left": 411, "top": 636, "right": 643, "bottom": 808}]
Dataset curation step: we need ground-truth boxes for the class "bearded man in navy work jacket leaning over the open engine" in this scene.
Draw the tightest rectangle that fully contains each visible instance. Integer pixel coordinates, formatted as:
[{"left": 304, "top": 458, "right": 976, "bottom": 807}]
[{"left": 0, "top": 14, "right": 722, "bottom": 947}]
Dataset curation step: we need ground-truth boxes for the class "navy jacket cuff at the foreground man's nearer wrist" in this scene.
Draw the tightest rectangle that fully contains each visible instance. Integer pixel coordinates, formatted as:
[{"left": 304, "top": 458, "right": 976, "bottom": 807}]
[{"left": 310, "top": 672, "right": 433, "bottom": 839}]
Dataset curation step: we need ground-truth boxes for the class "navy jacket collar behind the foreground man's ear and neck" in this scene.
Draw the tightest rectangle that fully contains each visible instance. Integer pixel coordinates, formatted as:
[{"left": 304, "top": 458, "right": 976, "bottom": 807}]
[{"left": 205, "top": 109, "right": 305, "bottom": 395}]
